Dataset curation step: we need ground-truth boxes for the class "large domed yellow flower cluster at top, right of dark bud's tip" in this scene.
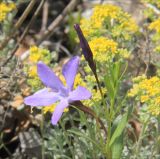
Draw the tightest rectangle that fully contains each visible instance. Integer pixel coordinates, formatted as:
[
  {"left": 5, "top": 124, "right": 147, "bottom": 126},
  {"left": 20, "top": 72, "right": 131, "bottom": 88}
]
[{"left": 81, "top": 4, "right": 138, "bottom": 38}]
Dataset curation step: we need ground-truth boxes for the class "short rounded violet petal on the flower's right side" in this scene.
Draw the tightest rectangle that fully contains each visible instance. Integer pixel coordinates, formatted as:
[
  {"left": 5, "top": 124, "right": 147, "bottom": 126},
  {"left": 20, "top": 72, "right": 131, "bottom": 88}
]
[{"left": 69, "top": 86, "right": 91, "bottom": 102}]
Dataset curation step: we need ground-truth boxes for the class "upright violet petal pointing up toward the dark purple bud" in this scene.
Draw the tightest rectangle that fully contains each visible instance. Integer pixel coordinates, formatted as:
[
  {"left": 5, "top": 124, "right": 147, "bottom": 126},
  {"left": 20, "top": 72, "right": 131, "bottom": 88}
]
[{"left": 62, "top": 56, "right": 79, "bottom": 90}]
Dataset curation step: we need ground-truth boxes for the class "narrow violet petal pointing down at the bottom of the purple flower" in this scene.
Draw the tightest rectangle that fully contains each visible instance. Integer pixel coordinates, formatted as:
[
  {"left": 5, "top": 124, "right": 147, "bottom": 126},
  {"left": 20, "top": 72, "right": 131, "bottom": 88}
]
[{"left": 51, "top": 99, "right": 68, "bottom": 125}]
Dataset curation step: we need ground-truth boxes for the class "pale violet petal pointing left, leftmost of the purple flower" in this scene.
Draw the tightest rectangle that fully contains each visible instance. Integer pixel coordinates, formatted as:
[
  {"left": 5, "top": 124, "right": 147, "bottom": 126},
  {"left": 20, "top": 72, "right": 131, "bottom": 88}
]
[{"left": 24, "top": 88, "right": 59, "bottom": 106}]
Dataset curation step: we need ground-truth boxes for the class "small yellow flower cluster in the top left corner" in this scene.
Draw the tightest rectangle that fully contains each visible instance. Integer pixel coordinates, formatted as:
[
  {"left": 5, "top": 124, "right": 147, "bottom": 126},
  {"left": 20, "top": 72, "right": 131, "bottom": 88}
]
[{"left": 0, "top": 2, "right": 16, "bottom": 22}]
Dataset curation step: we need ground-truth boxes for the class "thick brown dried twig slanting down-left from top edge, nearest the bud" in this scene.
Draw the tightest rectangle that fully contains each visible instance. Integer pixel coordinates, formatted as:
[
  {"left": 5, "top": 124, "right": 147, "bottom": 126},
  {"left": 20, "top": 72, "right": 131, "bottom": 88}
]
[{"left": 37, "top": 0, "right": 78, "bottom": 45}]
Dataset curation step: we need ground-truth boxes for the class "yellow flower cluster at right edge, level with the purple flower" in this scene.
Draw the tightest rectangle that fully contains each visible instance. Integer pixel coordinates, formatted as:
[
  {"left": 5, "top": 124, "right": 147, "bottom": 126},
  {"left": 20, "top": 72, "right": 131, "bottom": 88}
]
[{"left": 128, "top": 76, "right": 160, "bottom": 116}]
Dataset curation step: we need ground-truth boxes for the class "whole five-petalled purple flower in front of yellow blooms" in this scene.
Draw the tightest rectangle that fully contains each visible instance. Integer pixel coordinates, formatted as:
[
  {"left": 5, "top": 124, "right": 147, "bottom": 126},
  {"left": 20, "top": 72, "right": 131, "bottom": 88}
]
[{"left": 24, "top": 56, "right": 91, "bottom": 125}]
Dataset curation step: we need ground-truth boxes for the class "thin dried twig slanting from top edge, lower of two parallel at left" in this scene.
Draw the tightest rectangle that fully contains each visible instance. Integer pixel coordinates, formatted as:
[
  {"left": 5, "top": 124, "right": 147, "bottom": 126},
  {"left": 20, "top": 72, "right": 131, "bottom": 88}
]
[{"left": 1, "top": 0, "right": 45, "bottom": 66}]
